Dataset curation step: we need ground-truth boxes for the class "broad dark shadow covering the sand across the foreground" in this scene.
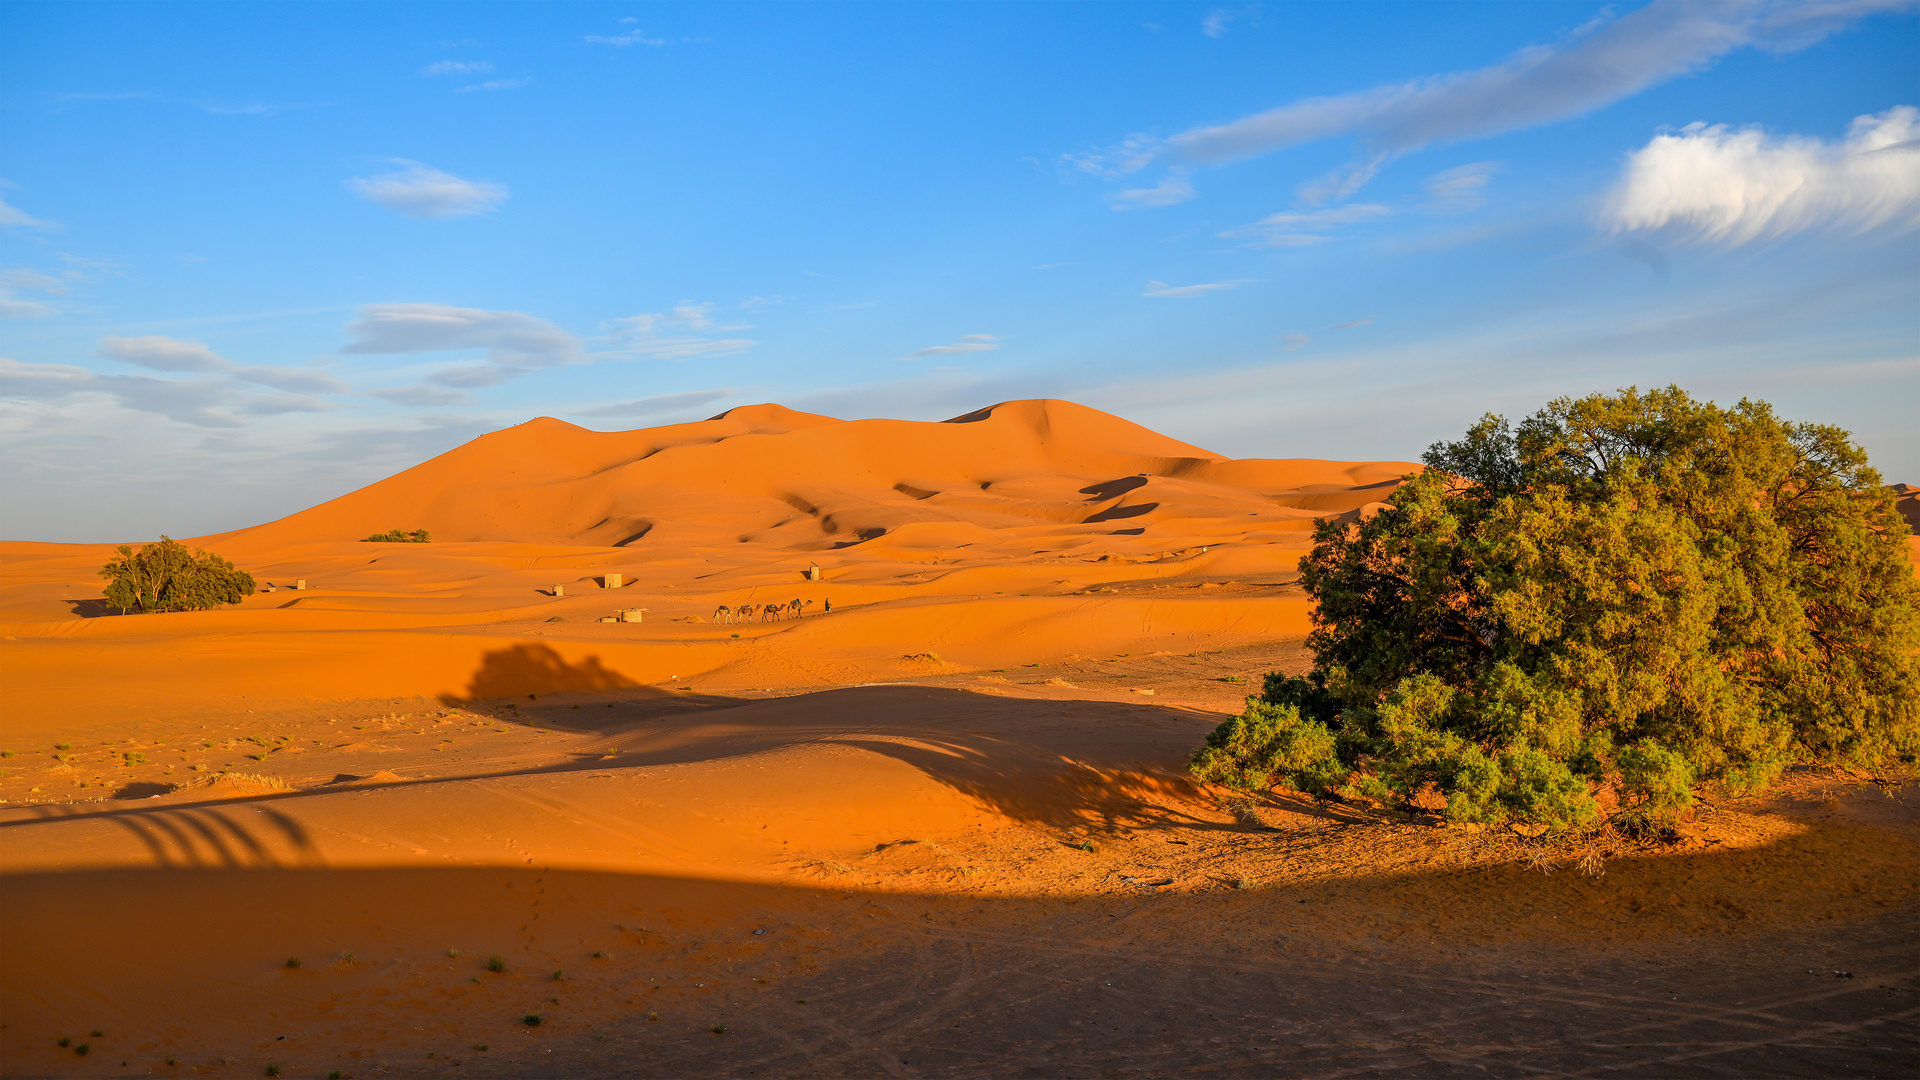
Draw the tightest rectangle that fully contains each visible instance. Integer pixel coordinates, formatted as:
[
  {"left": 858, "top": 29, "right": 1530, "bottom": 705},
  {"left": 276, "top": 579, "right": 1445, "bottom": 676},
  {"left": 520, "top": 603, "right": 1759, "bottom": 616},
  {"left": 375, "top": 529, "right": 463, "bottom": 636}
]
[{"left": 0, "top": 813, "right": 1920, "bottom": 1076}]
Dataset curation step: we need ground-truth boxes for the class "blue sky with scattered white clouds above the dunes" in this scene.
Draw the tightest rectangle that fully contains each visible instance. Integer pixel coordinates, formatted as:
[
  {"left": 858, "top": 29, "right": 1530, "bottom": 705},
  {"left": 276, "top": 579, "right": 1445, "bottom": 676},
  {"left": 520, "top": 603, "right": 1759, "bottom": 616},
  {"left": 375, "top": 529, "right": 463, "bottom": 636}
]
[{"left": 0, "top": 0, "right": 1920, "bottom": 540}]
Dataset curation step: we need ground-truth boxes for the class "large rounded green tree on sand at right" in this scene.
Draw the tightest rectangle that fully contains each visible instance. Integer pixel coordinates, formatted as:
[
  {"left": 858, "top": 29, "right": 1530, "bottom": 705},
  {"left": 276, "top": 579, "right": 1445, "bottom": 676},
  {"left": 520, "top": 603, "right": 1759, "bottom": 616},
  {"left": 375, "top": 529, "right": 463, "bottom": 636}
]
[{"left": 1192, "top": 386, "right": 1920, "bottom": 828}]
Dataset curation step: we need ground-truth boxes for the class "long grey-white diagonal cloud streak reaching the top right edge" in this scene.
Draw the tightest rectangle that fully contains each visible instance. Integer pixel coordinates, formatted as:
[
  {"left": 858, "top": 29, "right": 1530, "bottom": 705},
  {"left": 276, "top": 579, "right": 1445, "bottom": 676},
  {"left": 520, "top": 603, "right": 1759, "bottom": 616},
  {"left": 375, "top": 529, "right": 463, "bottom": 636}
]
[{"left": 1105, "top": 0, "right": 1912, "bottom": 206}]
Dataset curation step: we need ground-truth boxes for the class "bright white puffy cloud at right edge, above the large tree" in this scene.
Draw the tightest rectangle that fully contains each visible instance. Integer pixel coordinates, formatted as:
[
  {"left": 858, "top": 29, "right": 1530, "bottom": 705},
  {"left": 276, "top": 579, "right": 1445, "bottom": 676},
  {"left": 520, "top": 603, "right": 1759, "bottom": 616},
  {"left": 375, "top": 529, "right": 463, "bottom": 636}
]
[{"left": 1601, "top": 106, "right": 1920, "bottom": 248}]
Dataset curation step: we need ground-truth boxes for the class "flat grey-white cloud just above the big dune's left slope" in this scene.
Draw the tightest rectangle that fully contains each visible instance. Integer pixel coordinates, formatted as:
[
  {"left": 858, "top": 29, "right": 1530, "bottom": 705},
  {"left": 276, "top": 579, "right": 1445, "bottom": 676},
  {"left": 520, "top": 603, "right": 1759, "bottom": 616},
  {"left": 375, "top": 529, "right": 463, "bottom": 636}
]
[{"left": 340, "top": 304, "right": 584, "bottom": 388}]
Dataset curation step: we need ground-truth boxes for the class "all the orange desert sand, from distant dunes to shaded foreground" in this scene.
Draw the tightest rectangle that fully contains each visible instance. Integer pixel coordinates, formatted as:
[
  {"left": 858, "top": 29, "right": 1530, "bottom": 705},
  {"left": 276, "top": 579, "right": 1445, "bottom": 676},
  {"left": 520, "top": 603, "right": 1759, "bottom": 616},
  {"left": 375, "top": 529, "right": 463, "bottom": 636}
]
[{"left": 0, "top": 402, "right": 1920, "bottom": 1076}]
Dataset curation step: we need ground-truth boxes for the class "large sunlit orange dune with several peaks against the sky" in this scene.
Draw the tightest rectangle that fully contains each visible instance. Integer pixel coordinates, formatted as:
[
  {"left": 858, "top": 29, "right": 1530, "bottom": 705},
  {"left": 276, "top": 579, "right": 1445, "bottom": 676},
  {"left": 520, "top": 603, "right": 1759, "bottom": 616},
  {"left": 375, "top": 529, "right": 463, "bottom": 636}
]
[{"left": 205, "top": 400, "right": 1409, "bottom": 553}]
